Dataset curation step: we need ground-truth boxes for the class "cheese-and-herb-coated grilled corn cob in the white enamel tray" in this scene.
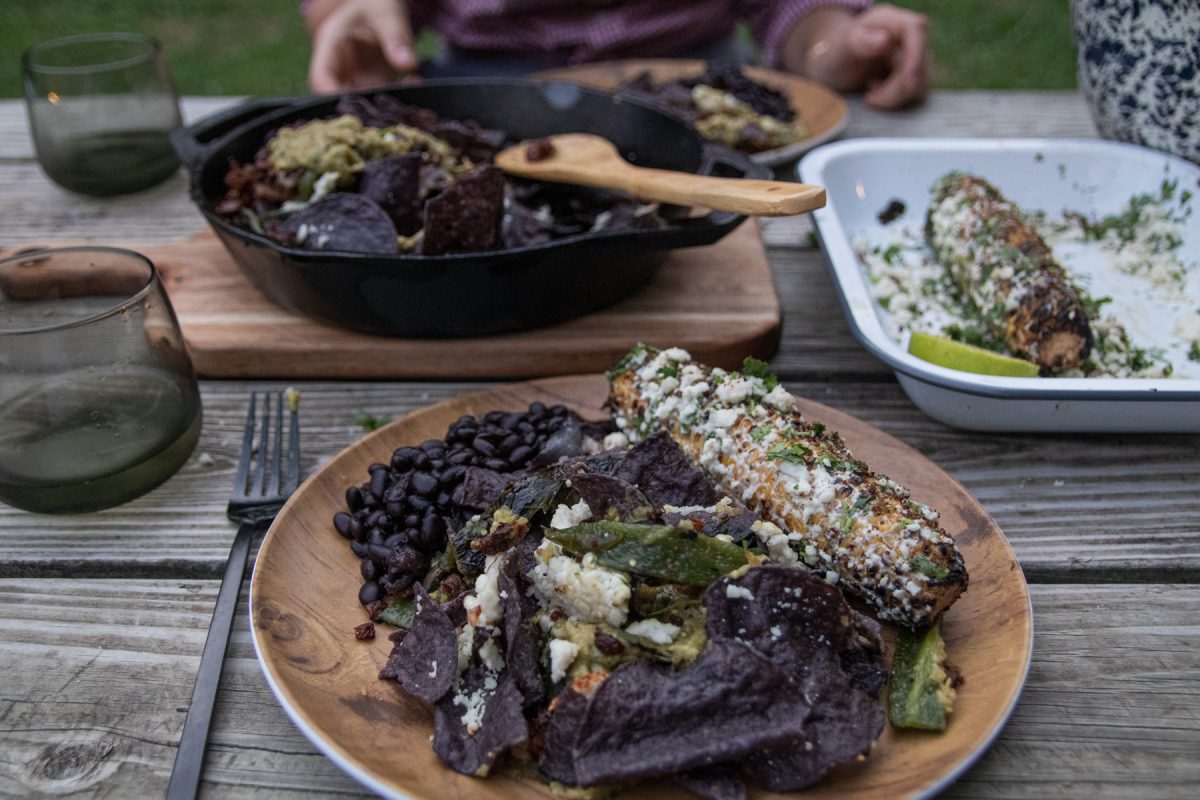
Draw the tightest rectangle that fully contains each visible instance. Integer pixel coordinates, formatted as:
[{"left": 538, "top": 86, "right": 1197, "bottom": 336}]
[{"left": 925, "top": 172, "right": 1092, "bottom": 373}]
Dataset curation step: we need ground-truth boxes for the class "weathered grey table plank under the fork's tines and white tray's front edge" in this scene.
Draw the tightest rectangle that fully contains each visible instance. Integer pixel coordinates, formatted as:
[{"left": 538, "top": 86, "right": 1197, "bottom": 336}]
[{"left": 0, "top": 380, "right": 1200, "bottom": 582}]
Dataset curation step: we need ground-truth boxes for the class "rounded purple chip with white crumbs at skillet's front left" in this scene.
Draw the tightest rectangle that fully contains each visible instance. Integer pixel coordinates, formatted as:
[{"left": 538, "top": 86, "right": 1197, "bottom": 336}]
[{"left": 269, "top": 192, "right": 400, "bottom": 255}]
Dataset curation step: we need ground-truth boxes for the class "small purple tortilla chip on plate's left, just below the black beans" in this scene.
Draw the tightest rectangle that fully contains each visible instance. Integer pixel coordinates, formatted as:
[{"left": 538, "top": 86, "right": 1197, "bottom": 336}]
[{"left": 379, "top": 583, "right": 458, "bottom": 703}]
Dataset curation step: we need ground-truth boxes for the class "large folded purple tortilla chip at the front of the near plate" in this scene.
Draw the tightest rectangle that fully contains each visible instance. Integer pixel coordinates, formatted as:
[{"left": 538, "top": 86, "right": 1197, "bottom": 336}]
[{"left": 546, "top": 639, "right": 810, "bottom": 787}]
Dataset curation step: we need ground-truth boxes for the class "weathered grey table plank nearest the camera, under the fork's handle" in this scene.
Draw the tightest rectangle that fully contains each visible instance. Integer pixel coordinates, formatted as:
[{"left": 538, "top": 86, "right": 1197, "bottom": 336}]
[{"left": 0, "top": 579, "right": 1200, "bottom": 800}]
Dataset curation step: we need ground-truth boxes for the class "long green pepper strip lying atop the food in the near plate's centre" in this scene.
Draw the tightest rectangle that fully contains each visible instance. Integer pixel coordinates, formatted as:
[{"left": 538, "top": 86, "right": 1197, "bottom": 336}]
[{"left": 545, "top": 521, "right": 750, "bottom": 587}]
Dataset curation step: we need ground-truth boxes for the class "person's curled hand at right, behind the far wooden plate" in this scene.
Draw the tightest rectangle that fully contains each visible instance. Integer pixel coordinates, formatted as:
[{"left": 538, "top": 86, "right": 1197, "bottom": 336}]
[{"left": 784, "top": 4, "right": 930, "bottom": 109}]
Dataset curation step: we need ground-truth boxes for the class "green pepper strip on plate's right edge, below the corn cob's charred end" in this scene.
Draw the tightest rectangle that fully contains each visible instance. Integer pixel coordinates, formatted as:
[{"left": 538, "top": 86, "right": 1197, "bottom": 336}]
[{"left": 888, "top": 625, "right": 956, "bottom": 730}]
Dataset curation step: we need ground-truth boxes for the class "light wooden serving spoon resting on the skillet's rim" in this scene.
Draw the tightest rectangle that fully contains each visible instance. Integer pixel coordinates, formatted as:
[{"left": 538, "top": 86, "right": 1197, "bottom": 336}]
[{"left": 496, "top": 133, "right": 824, "bottom": 217}]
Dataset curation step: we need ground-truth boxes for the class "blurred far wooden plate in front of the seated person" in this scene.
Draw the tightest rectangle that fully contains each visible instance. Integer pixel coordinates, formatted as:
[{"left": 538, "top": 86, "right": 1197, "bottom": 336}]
[{"left": 535, "top": 59, "right": 847, "bottom": 167}]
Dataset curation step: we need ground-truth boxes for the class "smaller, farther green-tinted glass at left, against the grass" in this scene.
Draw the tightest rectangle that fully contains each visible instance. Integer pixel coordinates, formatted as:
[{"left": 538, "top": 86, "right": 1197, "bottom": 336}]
[{"left": 22, "top": 34, "right": 180, "bottom": 197}]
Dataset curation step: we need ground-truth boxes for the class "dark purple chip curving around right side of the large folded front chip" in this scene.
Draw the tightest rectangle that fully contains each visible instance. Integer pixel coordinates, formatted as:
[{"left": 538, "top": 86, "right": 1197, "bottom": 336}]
[{"left": 704, "top": 566, "right": 887, "bottom": 792}]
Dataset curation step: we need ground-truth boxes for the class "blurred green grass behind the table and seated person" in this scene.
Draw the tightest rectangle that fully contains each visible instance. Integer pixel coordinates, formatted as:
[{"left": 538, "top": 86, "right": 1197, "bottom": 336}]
[{"left": 0, "top": 0, "right": 1075, "bottom": 97}]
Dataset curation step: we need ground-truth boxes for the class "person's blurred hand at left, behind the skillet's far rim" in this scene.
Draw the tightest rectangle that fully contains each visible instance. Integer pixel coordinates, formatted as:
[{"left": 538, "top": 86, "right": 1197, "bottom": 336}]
[{"left": 306, "top": 0, "right": 416, "bottom": 92}]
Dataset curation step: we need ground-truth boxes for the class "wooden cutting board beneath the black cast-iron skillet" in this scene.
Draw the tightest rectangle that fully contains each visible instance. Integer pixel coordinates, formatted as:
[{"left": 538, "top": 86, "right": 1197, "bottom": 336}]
[{"left": 2, "top": 221, "right": 781, "bottom": 379}]
